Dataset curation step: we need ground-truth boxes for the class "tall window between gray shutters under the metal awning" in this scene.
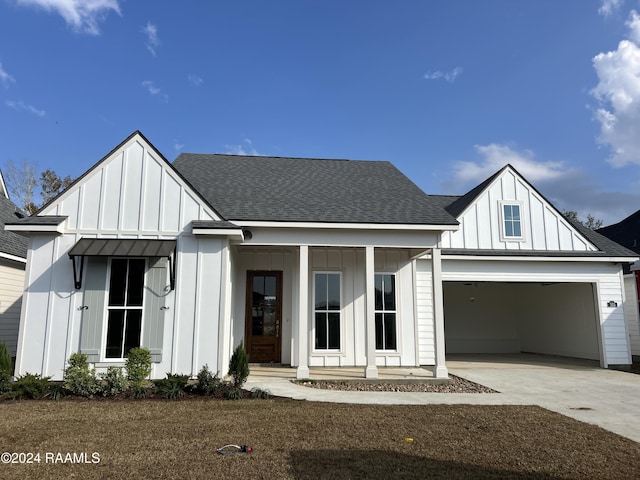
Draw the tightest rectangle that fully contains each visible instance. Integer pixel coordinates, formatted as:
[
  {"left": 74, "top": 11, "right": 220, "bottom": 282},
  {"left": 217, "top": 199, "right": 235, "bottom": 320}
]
[{"left": 105, "top": 258, "right": 145, "bottom": 358}]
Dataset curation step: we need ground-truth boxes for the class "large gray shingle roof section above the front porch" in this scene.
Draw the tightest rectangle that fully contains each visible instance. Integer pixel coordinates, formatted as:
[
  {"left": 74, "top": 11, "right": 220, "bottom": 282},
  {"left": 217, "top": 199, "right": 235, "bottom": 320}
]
[{"left": 173, "top": 153, "right": 458, "bottom": 225}]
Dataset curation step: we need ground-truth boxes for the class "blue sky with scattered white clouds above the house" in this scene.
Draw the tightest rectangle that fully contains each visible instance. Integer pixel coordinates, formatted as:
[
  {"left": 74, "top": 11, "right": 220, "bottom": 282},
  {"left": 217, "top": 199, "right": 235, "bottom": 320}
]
[{"left": 0, "top": 0, "right": 640, "bottom": 225}]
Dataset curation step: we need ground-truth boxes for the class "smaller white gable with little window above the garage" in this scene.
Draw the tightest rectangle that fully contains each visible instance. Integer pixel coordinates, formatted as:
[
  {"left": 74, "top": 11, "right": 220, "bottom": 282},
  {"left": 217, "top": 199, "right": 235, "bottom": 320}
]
[{"left": 442, "top": 166, "right": 598, "bottom": 252}]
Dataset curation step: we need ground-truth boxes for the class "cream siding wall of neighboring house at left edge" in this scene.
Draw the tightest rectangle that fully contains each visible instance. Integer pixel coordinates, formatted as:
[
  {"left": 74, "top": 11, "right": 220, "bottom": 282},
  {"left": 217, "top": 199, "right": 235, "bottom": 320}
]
[{"left": 0, "top": 258, "right": 25, "bottom": 357}]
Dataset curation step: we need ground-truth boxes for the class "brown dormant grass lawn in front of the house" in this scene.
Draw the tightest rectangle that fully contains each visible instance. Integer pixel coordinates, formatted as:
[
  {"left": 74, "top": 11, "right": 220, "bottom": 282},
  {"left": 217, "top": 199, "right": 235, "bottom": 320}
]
[{"left": 0, "top": 399, "right": 640, "bottom": 480}]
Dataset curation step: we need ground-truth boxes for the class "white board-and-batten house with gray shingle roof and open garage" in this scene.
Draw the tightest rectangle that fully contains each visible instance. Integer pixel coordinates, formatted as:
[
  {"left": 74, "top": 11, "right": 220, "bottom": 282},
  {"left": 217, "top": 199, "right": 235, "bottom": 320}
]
[{"left": 7, "top": 132, "right": 638, "bottom": 378}]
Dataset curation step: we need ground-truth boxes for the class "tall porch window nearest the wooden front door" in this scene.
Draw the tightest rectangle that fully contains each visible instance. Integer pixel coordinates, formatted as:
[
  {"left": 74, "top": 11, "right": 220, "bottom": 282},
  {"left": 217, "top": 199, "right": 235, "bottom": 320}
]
[{"left": 314, "top": 273, "right": 340, "bottom": 350}]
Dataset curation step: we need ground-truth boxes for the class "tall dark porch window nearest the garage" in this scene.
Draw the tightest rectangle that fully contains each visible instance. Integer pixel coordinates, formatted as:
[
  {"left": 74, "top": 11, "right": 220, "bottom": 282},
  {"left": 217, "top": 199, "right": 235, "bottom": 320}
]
[{"left": 375, "top": 273, "right": 397, "bottom": 350}]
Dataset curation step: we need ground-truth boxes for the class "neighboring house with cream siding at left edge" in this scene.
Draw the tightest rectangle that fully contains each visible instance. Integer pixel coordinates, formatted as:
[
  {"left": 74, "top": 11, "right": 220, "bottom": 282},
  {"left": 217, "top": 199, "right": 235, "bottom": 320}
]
[{"left": 0, "top": 172, "right": 27, "bottom": 357}]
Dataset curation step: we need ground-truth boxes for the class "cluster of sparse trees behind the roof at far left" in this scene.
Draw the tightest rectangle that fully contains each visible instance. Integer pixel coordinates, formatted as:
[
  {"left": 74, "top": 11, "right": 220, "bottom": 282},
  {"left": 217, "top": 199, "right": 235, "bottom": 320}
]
[{"left": 5, "top": 160, "right": 73, "bottom": 215}]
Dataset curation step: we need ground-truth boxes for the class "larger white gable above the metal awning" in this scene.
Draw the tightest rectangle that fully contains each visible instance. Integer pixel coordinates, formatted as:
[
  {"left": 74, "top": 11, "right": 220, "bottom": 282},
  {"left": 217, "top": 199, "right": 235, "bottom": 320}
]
[{"left": 38, "top": 132, "right": 219, "bottom": 235}]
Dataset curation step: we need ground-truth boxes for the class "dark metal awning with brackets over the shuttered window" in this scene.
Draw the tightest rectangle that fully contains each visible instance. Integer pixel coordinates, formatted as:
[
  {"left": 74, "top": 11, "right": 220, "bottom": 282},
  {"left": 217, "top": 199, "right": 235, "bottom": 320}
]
[{"left": 69, "top": 238, "right": 176, "bottom": 290}]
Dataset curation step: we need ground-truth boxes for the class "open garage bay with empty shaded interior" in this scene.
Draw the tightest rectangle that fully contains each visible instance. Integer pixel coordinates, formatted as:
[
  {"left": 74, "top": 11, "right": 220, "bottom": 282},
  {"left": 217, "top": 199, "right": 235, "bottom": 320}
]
[{"left": 443, "top": 281, "right": 600, "bottom": 360}]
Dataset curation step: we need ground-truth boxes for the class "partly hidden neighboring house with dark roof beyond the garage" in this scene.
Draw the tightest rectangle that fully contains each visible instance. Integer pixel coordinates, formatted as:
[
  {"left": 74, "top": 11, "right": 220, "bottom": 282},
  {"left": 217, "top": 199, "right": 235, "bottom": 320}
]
[{"left": 598, "top": 210, "right": 640, "bottom": 359}]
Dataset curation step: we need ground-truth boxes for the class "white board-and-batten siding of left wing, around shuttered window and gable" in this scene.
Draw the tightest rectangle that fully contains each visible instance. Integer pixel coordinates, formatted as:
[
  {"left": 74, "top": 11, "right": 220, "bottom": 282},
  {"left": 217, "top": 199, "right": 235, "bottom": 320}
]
[{"left": 17, "top": 135, "right": 228, "bottom": 380}]
